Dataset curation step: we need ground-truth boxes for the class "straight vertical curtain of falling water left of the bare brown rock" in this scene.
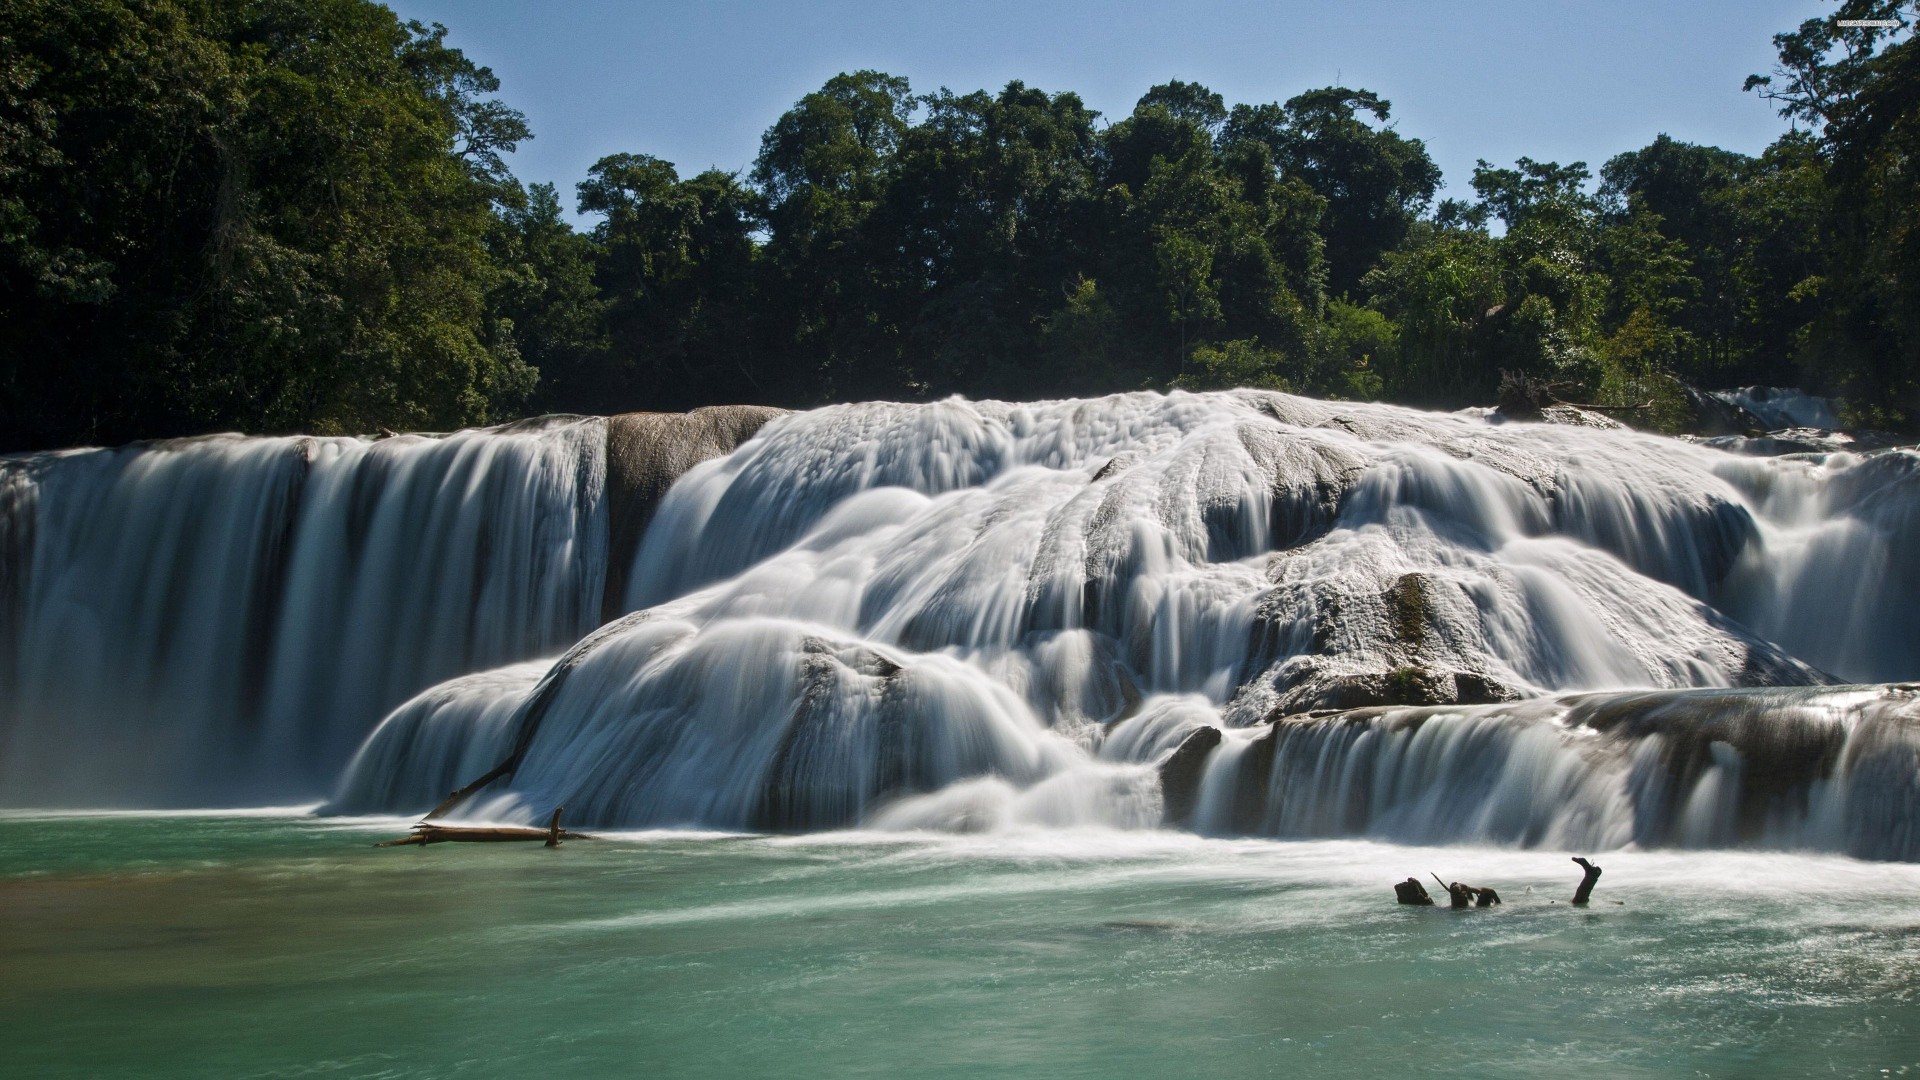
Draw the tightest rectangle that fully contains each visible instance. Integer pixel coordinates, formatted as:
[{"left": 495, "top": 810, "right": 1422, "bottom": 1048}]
[{"left": 0, "top": 419, "right": 607, "bottom": 805}]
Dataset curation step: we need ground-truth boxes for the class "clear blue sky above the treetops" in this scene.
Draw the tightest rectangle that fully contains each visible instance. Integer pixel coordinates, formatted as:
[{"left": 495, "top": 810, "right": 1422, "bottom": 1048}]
[{"left": 390, "top": 0, "right": 1832, "bottom": 220}]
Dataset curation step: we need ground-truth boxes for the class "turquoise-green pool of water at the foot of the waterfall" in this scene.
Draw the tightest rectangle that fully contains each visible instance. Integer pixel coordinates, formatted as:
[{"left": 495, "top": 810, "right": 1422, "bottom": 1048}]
[{"left": 0, "top": 811, "right": 1920, "bottom": 1078}]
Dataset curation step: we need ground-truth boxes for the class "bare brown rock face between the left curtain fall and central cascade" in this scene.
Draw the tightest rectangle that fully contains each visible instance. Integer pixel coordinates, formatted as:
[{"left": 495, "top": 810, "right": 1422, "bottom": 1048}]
[{"left": 601, "top": 405, "right": 787, "bottom": 623}]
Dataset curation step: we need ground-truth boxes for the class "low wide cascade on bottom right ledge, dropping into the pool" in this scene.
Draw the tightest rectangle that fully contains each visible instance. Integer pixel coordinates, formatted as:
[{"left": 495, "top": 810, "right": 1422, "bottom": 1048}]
[{"left": 1182, "top": 686, "right": 1920, "bottom": 861}]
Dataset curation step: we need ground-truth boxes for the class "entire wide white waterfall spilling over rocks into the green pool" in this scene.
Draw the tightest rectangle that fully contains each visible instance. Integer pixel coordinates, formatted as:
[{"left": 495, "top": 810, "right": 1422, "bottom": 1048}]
[{"left": 0, "top": 392, "right": 1920, "bottom": 859}]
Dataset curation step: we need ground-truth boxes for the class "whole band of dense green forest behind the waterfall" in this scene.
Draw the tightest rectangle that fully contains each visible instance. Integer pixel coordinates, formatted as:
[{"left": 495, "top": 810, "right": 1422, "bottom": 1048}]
[{"left": 0, "top": 0, "right": 1920, "bottom": 450}]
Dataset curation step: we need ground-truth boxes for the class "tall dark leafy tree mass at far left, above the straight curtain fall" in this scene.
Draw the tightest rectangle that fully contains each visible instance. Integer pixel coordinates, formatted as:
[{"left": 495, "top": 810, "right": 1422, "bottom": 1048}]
[{"left": 0, "top": 0, "right": 536, "bottom": 448}]
